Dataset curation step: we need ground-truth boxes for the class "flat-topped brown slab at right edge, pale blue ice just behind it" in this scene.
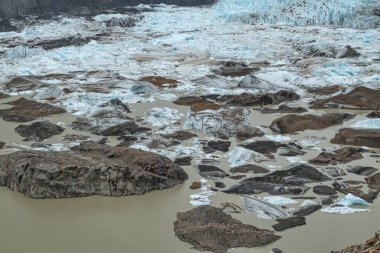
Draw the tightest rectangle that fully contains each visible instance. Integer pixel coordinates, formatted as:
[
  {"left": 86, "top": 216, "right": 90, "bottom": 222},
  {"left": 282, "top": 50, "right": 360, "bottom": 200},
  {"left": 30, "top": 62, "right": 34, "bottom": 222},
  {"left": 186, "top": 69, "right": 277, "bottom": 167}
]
[{"left": 330, "top": 128, "right": 380, "bottom": 148}]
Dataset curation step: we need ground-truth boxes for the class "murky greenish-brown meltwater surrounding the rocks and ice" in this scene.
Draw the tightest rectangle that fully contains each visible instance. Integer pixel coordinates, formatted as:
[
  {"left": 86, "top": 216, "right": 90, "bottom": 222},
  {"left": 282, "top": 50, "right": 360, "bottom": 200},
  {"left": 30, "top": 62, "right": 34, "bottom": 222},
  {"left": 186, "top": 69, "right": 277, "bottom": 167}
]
[{"left": 0, "top": 98, "right": 380, "bottom": 253}]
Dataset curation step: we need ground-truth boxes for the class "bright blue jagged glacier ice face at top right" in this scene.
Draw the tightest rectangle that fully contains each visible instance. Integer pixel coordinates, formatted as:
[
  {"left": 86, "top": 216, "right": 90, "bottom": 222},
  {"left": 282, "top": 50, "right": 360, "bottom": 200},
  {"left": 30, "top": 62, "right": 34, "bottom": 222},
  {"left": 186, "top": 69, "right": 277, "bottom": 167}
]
[{"left": 214, "top": 0, "right": 380, "bottom": 28}]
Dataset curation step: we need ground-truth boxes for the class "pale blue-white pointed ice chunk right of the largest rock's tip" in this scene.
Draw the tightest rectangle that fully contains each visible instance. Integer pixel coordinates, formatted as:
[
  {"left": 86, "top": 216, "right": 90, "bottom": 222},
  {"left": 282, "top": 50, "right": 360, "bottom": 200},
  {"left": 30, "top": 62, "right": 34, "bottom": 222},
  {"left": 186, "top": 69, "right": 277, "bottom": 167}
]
[{"left": 226, "top": 147, "right": 268, "bottom": 167}]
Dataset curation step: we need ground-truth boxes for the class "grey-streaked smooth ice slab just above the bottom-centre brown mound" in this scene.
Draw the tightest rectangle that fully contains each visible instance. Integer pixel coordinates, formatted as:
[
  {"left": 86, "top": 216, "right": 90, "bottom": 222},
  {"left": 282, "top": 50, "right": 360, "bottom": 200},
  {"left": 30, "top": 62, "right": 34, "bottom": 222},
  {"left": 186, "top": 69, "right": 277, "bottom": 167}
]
[{"left": 240, "top": 195, "right": 288, "bottom": 219}]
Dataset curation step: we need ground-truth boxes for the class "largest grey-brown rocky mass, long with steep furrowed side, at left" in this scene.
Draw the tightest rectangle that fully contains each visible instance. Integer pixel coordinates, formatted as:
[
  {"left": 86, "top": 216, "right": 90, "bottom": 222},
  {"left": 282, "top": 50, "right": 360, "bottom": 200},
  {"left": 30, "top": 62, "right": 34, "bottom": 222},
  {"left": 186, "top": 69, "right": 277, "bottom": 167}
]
[{"left": 0, "top": 142, "right": 188, "bottom": 198}]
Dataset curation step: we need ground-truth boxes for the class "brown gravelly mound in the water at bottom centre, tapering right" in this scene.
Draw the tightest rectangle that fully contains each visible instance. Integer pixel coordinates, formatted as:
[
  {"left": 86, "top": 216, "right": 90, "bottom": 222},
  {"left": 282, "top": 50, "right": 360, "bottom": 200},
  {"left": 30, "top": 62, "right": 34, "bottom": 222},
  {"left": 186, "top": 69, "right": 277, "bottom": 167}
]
[{"left": 174, "top": 206, "right": 281, "bottom": 253}]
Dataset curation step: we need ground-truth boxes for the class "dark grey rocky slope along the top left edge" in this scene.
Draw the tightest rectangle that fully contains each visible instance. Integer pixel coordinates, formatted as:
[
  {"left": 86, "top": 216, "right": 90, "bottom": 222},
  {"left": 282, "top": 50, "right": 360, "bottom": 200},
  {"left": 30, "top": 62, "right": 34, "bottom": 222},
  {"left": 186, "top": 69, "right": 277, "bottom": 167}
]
[{"left": 0, "top": 0, "right": 216, "bottom": 18}]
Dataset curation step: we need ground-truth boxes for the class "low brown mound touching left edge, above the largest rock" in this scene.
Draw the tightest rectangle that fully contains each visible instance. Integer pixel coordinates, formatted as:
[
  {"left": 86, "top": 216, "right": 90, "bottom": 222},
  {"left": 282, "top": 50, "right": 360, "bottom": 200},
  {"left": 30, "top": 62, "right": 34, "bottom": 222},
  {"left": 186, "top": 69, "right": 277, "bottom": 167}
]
[{"left": 0, "top": 98, "right": 66, "bottom": 122}]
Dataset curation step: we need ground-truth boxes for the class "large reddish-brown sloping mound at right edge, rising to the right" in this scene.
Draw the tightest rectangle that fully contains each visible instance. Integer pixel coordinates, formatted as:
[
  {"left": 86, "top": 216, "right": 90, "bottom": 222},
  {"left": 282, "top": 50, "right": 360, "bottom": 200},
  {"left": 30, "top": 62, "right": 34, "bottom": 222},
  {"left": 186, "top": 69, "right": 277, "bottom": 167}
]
[{"left": 312, "top": 87, "right": 380, "bottom": 110}]
